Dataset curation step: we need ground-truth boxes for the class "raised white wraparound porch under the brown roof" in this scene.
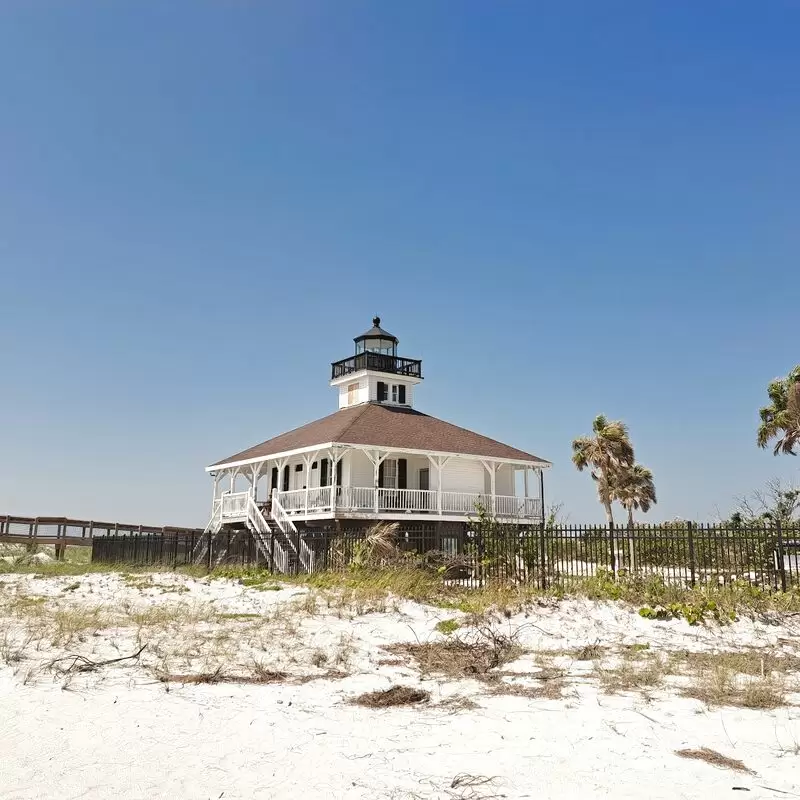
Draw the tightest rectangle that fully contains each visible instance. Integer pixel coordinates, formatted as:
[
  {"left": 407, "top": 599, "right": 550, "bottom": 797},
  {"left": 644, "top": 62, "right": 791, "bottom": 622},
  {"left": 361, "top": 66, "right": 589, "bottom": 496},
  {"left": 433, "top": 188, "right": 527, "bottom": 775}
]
[{"left": 212, "top": 444, "right": 543, "bottom": 524}]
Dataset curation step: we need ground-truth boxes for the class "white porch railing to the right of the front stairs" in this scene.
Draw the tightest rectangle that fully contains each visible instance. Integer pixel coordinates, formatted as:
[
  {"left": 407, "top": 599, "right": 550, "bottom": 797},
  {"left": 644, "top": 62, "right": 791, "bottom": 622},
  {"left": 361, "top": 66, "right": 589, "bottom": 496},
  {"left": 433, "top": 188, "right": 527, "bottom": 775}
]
[{"left": 273, "top": 486, "right": 541, "bottom": 520}]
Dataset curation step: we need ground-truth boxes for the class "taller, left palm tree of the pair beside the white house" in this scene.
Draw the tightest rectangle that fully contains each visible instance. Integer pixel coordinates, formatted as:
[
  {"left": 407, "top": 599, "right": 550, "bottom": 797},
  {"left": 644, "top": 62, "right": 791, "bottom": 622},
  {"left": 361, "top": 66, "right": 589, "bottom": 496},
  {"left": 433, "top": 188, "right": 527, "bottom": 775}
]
[{"left": 572, "top": 414, "right": 633, "bottom": 527}]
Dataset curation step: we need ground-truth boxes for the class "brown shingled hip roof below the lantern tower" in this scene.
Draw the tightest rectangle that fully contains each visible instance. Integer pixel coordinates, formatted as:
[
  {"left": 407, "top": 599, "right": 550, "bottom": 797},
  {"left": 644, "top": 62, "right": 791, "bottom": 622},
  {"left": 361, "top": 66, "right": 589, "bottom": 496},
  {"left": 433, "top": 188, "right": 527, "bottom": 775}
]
[{"left": 211, "top": 403, "right": 548, "bottom": 467}]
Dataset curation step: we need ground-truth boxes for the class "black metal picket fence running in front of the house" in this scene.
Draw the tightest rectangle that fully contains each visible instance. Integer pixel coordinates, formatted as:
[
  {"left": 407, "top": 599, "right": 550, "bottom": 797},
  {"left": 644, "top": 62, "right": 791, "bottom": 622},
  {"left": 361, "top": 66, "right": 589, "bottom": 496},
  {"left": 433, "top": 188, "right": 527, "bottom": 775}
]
[{"left": 92, "top": 523, "right": 800, "bottom": 590}]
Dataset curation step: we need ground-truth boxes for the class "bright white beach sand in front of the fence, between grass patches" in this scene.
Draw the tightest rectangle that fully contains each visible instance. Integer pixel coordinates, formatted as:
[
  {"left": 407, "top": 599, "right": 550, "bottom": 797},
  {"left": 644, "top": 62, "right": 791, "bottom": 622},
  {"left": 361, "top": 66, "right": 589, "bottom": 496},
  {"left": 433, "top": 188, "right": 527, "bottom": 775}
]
[{"left": 0, "top": 574, "right": 800, "bottom": 800}]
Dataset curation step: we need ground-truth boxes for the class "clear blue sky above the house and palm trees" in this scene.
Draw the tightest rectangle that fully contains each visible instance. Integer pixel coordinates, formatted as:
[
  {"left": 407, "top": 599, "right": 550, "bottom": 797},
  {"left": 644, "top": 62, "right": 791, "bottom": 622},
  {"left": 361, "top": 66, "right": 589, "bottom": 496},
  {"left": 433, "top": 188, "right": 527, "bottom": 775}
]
[{"left": 0, "top": 0, "right": 800, "bottom": 524}]
